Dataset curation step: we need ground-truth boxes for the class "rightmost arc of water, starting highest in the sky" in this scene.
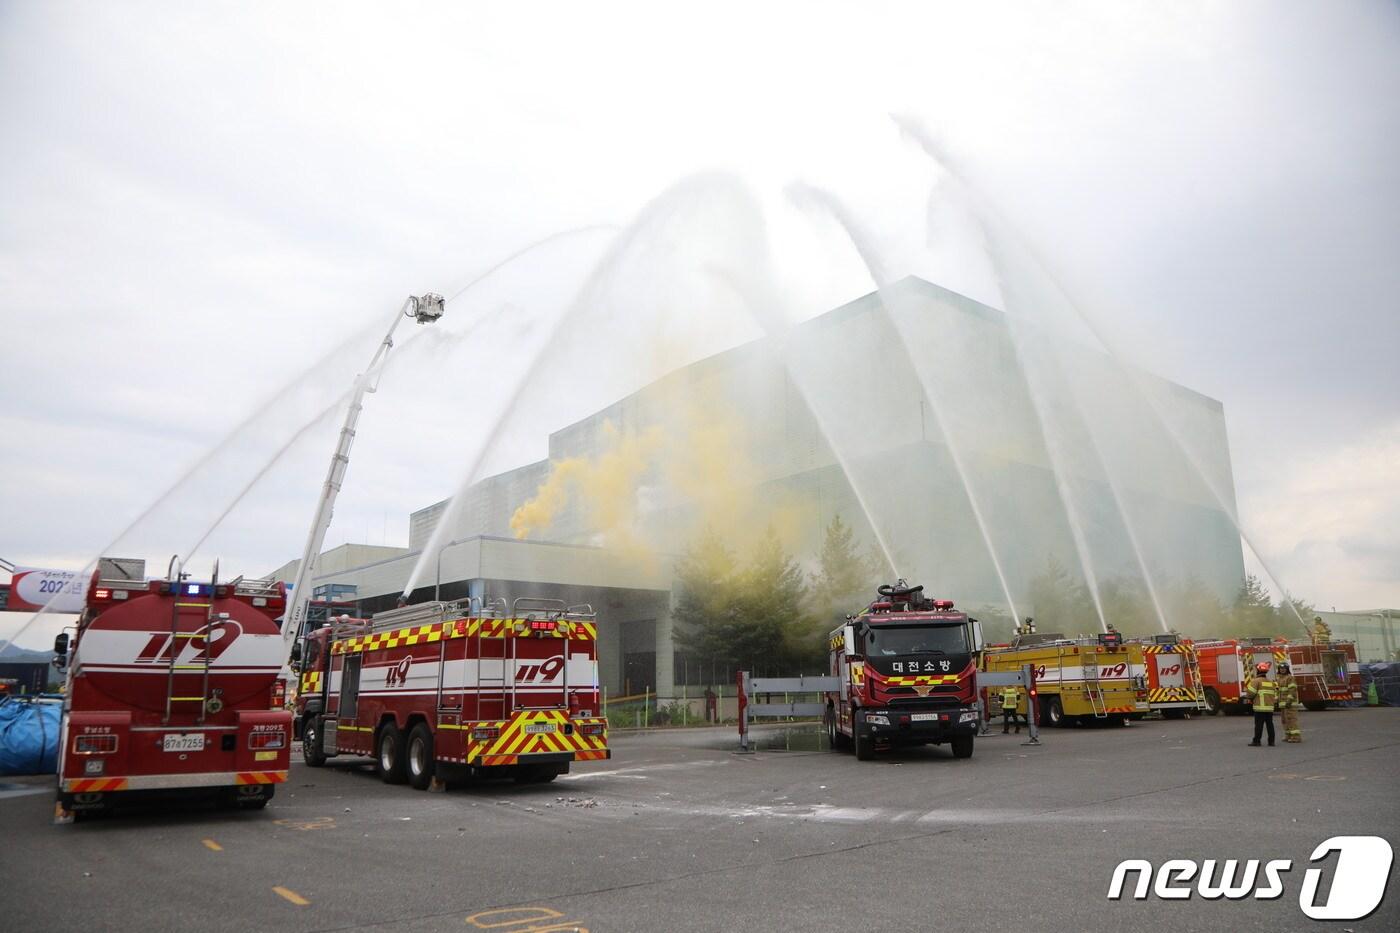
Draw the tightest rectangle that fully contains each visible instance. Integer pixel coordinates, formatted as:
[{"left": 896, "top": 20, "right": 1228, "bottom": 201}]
[{"left": 895, "top": 118, "right": 1308, "bottom": 630}]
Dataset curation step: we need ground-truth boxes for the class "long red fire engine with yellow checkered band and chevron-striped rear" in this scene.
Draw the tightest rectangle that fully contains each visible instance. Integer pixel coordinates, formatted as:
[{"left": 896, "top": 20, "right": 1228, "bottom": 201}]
[{"left": 293, "top": 597, "right": 612, "bottom": 789}]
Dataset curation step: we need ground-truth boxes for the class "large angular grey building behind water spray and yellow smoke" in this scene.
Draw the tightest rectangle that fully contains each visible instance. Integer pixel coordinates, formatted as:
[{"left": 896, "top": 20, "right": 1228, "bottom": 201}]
[{"left": 277, "top": 279, "right": 1243, "bottom": 696}]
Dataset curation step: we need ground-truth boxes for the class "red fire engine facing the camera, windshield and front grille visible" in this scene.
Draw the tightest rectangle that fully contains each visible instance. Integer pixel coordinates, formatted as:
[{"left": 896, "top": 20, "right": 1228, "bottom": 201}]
[{"left": 826, "top": 580, "right": 981, "bottom": 761}]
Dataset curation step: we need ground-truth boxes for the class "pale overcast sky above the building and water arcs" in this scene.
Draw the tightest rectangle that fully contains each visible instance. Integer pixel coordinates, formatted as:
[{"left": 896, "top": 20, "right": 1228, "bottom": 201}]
[{"left": 0, "top": 1, "right": 1400, "bottom": 637}]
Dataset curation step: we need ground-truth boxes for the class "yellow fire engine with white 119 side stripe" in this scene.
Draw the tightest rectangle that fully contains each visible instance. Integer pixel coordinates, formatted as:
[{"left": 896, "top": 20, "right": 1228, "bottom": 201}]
[{"left": 981, "top": 632, "right": 1149, "bottom": 726}]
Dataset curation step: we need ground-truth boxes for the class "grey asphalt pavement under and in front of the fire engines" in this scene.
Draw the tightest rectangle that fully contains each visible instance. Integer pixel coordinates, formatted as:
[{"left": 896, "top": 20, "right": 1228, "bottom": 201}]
[{"left": 0, "top": 709, "right": 1400, "bottom": 933}]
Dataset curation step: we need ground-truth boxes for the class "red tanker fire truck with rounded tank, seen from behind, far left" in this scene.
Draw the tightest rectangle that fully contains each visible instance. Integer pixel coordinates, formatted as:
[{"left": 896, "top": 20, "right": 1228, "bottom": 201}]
[{"left": 53, "top": 559, "right": 291, "bottom": 820}]
